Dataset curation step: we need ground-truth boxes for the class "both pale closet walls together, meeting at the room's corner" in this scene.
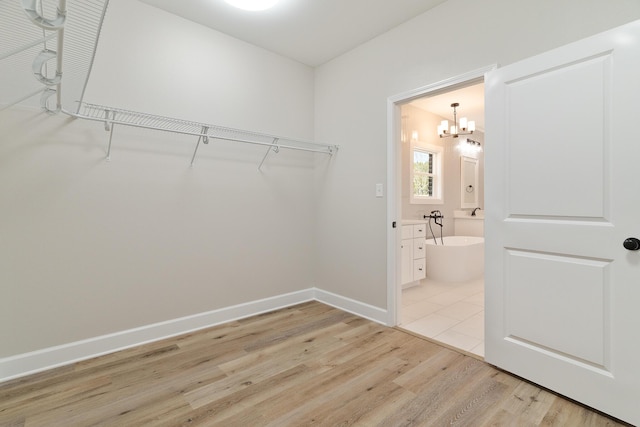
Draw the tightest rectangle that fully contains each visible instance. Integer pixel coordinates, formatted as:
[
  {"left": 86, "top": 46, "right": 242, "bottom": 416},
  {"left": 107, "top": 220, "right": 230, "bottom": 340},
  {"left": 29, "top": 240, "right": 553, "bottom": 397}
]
[{"left": 5, "top": 0, "right": 640, "bottom": 378}]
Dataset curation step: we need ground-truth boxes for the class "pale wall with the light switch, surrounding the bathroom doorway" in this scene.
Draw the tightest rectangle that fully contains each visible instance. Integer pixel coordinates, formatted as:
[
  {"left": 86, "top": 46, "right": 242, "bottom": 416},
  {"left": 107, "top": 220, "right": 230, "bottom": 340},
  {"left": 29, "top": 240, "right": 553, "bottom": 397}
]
[{"left": 315, "top": 0, "right": 640, "bottom": 308}]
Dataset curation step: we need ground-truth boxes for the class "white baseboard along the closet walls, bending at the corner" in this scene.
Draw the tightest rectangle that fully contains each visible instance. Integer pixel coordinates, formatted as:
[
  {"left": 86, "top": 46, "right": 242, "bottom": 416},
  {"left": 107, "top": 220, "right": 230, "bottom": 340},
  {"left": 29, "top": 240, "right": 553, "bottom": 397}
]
[{"left": 0, "top": 288, "right": 387, "bottom": 382}]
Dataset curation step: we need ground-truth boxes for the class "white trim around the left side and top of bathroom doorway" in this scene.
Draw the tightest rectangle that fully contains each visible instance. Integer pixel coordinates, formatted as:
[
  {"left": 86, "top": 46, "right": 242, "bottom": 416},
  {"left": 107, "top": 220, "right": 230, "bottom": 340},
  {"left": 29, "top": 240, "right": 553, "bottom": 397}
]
[{"left": 387, "top": 64, "right": 498, "bottom": 326}]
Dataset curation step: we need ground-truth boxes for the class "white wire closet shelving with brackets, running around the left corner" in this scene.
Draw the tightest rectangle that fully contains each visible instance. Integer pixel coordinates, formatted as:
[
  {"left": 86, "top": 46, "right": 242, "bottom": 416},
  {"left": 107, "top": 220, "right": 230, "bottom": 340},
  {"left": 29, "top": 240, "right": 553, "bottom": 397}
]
[{"left": 0, "top": 0, "right": 338, "bottom": 169}]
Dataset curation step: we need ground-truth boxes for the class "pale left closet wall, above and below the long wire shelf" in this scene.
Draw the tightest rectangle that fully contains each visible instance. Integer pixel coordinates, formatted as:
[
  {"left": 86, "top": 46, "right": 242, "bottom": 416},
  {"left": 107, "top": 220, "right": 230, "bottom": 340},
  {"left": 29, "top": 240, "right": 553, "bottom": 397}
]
[{"left": 0, "top": 0, "right": 318, "bottom": 362}]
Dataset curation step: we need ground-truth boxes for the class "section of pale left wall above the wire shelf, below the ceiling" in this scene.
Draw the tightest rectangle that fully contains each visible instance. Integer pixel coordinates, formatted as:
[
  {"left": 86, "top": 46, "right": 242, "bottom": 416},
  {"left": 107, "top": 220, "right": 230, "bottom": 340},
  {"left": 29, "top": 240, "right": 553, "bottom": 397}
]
[{"left": 85, "top": 0, "right": 314, "bottom": 139}]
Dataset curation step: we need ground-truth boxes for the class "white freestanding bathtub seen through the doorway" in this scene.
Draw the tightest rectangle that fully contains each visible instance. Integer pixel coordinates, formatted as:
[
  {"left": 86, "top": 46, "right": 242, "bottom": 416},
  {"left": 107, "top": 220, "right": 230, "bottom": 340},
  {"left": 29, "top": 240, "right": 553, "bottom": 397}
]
[{"left": 426, "top": 236, "right": 484, "bottom": 282}]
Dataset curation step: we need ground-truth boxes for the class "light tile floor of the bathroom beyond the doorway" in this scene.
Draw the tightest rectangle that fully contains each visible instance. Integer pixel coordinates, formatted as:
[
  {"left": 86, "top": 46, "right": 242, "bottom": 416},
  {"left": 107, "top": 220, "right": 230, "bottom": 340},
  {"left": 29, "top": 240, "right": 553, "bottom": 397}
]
[{"left": 400, "top": 279, "right": 484, "bottom": 357}]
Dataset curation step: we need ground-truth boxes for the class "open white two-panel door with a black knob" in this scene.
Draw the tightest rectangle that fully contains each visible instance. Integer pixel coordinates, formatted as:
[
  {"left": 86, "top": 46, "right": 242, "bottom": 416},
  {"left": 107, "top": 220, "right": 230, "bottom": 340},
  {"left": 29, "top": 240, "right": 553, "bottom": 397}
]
[{"left": 485, "top": 21, "right": 640, "bottom": 425}]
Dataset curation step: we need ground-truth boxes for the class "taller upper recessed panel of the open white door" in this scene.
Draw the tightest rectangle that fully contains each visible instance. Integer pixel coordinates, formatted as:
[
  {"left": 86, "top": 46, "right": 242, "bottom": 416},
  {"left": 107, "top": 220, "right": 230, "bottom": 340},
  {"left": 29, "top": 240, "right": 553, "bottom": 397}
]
[{"left": 505, "top": 54, "right": 611, "bottom": 218}]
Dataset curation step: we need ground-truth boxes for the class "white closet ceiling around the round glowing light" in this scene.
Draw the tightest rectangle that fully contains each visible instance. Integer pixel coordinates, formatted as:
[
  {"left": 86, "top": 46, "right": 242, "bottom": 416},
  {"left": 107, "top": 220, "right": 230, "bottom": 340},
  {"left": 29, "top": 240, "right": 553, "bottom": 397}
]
[{"left": 141, "top": 0, "right": 446, "bottom": 67}]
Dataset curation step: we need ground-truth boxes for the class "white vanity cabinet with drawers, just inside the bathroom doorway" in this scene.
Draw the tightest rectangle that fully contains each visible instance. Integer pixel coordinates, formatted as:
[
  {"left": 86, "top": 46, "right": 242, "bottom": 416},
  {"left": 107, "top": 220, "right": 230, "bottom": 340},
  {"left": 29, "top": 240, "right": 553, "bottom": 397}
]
[{"left": 400, "top": 223, "right": 427, "bottom": 287}]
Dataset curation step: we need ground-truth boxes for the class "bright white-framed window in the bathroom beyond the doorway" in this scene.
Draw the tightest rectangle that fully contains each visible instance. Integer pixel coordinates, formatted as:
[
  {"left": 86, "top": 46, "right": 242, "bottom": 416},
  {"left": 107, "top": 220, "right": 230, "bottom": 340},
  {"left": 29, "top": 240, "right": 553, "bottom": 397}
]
[{"left": 409, "top": 145, "right": 443, "bottom": 204}]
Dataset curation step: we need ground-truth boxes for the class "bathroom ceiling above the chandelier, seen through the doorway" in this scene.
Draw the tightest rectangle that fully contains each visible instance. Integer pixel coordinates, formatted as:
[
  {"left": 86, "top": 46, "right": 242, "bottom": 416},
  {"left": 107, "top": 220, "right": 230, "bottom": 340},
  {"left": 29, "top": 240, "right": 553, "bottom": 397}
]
[{"left": 409, "top": 83, "right": 484, "bottom": 132}]
